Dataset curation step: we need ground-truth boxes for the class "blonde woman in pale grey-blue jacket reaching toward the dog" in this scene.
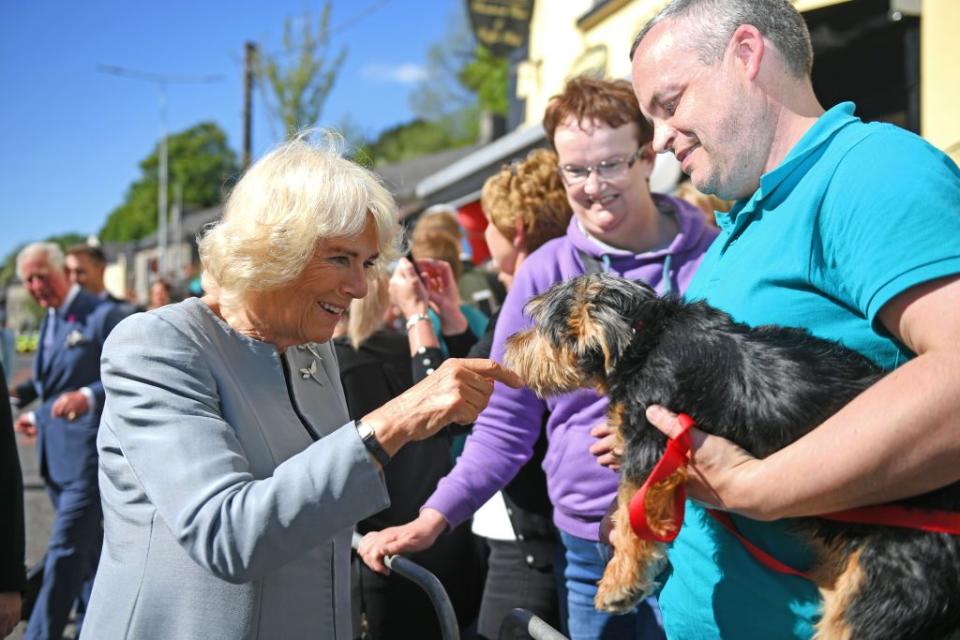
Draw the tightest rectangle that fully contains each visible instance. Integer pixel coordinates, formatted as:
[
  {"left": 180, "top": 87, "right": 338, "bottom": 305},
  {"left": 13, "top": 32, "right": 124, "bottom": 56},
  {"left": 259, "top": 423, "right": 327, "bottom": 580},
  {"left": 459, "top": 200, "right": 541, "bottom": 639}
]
[{"left": 83, "top": 139, "right": 517, "bottom": 640}]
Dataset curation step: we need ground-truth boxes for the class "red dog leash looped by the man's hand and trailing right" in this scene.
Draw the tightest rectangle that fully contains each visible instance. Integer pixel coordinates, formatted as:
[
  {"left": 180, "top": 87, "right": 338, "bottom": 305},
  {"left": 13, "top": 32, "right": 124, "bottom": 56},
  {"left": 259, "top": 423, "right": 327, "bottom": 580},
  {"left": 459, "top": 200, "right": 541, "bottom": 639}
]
[{"left": 630, "top": 413, "right": 960, "bottom": 580}]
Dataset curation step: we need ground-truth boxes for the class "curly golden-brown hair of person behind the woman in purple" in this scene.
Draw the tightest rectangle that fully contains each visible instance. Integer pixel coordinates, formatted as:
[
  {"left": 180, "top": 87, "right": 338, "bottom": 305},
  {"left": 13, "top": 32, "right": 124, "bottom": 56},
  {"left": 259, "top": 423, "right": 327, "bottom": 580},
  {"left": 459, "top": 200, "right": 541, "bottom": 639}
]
[{"left": 480, "top": 149, "right": 573, "bottom": 253}]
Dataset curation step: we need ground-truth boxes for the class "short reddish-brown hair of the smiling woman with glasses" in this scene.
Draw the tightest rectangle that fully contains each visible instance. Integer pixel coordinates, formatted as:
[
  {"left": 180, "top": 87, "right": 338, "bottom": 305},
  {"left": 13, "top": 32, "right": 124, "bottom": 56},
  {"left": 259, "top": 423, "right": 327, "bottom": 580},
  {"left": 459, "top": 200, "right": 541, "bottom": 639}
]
[{"left": 543, "top": 76, "right": 653, "bottom": 147}]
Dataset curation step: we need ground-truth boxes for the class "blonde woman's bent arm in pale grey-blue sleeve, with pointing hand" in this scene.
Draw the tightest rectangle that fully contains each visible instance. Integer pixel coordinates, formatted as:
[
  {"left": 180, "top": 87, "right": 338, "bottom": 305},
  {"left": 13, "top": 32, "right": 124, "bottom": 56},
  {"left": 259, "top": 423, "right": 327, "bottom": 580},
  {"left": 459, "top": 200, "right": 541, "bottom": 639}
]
[{"left": 106, "top": 314, "right": 519, "bottom": 583}]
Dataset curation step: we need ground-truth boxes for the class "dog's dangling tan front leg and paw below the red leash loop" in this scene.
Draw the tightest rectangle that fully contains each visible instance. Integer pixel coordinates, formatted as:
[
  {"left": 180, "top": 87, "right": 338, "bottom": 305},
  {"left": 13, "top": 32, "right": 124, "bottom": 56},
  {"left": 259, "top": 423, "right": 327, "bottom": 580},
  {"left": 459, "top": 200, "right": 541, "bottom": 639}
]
[{"left": 594, "top": 481, "right": 664, "bottom": 613}]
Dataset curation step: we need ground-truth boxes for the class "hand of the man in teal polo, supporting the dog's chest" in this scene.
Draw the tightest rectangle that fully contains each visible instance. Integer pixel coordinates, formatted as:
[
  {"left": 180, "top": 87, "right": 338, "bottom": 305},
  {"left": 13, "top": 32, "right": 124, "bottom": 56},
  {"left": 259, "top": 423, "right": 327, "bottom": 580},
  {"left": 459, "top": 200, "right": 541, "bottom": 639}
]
[{"left": 646, "top": 405, "right": 768, "bottom": 520}]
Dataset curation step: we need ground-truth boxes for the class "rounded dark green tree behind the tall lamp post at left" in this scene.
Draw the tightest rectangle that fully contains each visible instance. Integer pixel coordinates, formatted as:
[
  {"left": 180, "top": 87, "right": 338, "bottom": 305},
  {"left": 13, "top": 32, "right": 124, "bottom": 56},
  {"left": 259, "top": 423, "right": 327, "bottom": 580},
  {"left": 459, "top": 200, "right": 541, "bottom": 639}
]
[{"left": 100, "top": 122, "right": 240, "bottom": 242}]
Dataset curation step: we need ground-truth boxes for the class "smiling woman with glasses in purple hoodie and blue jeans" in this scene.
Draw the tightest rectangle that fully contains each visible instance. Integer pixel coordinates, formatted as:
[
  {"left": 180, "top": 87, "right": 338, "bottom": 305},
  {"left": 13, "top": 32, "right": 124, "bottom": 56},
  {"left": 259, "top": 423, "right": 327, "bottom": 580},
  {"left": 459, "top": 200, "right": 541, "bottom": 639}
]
[{"left": 361, "top": 78, "right": 716, "bottom": 640}]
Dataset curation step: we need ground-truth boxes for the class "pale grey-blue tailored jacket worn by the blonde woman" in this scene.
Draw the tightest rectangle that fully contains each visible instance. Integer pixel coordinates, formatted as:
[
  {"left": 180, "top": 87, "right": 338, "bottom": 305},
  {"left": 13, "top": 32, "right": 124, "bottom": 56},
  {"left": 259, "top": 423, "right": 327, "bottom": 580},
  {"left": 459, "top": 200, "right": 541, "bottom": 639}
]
[{"left": 82, "top": 298, "right": 389, "bottom": 640}]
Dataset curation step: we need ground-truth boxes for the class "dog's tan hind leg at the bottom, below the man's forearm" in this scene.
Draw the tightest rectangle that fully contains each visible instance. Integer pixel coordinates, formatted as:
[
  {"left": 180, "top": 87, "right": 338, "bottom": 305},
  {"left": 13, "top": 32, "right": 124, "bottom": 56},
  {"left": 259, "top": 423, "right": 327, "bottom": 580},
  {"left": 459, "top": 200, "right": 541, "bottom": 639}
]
[{"left": 813, "top": 548, "right": 864, "bottom": 640}]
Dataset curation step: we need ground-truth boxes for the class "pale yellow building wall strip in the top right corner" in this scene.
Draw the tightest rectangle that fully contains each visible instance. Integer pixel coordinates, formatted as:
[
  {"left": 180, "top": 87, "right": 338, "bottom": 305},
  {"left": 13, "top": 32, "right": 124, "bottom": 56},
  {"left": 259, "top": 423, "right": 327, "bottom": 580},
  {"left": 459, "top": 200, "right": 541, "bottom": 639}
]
[{"left": 920, "top": 0, "right": 960, "bottom": 162}]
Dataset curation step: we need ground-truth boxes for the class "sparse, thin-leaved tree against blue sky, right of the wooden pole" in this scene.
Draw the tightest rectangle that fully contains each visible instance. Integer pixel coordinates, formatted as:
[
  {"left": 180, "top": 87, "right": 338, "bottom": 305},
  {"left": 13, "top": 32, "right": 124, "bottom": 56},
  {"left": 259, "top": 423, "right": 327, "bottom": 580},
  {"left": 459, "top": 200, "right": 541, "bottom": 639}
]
[{"left": 256, "top": 2, "right": 347, "bottom": 139}]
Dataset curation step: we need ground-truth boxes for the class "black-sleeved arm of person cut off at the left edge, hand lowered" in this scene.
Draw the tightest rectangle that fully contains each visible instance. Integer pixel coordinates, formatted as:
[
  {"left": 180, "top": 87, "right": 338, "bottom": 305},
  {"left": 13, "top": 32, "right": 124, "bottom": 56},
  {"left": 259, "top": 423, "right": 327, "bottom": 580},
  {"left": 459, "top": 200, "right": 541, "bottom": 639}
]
[{"left": 0, "top": 365, "right": 25, "bottom": 638}]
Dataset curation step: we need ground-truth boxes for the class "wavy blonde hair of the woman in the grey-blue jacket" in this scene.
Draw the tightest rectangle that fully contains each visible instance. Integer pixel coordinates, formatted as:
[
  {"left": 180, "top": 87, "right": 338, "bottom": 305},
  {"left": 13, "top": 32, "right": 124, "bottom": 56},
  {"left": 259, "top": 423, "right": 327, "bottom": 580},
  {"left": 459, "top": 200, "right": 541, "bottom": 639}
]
[{"left": 198, "top": 131, "right": 401, "bottom": 301}]
